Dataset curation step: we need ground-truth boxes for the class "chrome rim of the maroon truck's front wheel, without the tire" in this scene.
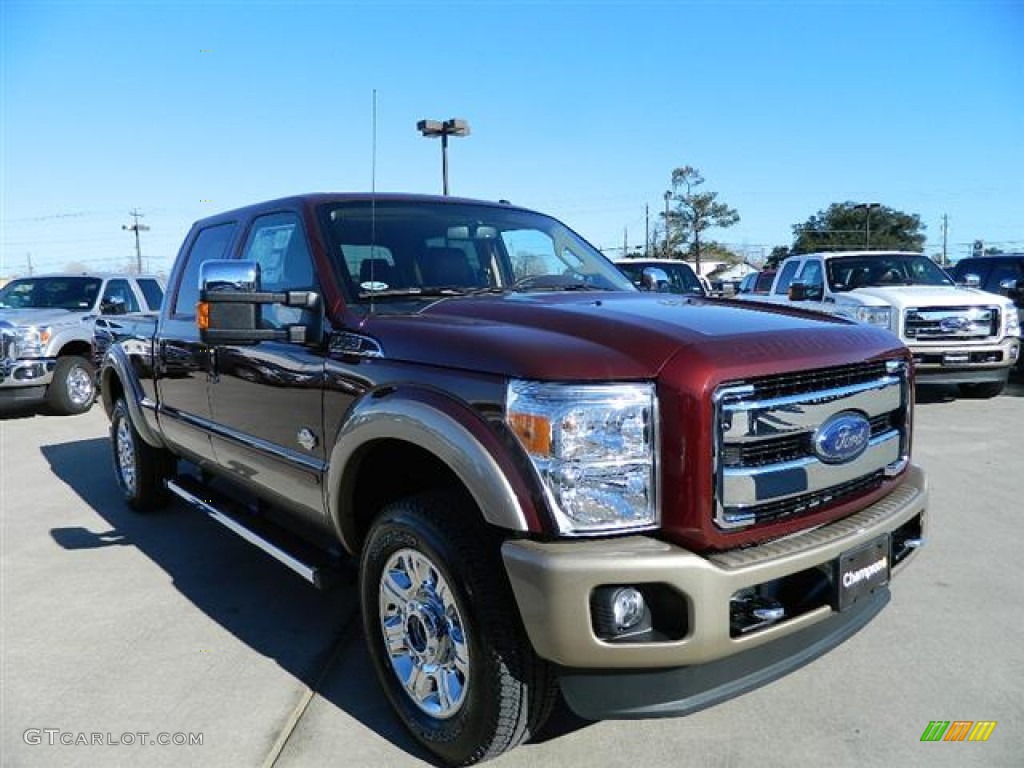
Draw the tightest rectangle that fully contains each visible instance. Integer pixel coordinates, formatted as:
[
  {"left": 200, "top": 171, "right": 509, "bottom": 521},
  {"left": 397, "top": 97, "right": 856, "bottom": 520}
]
[{"left": 379, "top": 549, "right": 469, "bottom": 720}]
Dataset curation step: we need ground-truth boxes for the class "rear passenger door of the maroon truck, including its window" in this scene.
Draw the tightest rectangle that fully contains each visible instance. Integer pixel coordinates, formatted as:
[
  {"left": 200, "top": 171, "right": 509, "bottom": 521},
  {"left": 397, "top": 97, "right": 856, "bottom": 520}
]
[{"left": 154, "top": 222, "right": 238, "bottom": 461}]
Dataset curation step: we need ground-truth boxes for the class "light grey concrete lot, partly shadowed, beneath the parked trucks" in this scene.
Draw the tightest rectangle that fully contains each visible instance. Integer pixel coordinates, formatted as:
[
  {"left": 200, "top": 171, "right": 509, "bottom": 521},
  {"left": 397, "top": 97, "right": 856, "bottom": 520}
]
[{"left": 0, "top": 381, "right": 1024, "bottom": 768}]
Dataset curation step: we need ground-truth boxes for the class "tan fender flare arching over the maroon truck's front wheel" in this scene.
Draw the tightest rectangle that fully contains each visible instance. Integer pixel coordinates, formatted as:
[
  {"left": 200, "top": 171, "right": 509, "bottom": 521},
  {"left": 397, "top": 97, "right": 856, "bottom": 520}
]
[{"left": 325, "top": 386, "right": 547, "bottom": 552}]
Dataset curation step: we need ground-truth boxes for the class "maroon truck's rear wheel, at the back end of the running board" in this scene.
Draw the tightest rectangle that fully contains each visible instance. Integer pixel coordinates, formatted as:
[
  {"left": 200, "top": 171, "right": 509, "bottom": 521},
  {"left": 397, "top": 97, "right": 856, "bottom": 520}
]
[{"left": 111, "top": 398, "right": 174, "bottom": 512}]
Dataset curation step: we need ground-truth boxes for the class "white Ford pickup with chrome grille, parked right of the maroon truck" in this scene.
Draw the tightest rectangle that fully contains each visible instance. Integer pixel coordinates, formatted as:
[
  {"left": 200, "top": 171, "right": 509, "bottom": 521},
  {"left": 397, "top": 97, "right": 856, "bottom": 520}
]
[{"left": 740, "top": 251, "right": 1021, "bottom": 397}]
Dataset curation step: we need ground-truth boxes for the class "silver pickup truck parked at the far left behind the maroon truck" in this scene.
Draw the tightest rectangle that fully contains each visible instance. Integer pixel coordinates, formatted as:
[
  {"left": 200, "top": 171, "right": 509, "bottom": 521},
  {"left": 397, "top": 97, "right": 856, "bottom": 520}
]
[{"left": 0, "top": 273, "right": 164, "bottom": 415}]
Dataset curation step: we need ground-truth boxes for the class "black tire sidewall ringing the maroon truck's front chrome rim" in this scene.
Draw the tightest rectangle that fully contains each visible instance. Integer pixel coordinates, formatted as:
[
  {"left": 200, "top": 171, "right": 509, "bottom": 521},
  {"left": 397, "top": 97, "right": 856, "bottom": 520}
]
[{"left": 359, "top": 512, "right": 500, "bottom": 763}]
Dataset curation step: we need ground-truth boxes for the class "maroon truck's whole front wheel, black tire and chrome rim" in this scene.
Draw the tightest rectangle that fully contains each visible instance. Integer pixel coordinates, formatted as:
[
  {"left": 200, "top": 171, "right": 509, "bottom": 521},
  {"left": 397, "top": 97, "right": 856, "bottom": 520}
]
[{"left": 359, "top": 494, "right": 557, "bottom": 765}]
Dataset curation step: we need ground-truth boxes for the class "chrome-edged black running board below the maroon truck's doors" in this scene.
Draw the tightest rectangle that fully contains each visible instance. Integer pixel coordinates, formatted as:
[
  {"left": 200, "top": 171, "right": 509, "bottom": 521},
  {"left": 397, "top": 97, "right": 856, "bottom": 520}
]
[{"left": 166, "top": 476, "right": 340, "bottom": 589}]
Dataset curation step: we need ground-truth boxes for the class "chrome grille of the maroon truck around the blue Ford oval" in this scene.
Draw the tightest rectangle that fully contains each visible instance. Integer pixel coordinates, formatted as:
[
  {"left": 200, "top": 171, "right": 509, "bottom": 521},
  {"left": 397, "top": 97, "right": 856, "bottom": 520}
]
[{"left": 714, "top": 360, "right": 910, "bottom": 529}]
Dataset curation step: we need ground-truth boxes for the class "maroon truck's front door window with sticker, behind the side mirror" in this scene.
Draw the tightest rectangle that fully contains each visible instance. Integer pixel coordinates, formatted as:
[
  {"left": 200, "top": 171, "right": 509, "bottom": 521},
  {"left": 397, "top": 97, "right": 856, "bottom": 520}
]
[{"left": 242, "top": 213, "right": 316, "bottom": 327}]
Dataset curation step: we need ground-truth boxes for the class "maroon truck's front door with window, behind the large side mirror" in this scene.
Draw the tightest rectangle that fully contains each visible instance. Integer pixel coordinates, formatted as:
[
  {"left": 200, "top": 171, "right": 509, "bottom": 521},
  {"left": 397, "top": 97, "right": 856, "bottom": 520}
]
[{"left": 204, "top": 211, "right": 326, "bottom": 519}]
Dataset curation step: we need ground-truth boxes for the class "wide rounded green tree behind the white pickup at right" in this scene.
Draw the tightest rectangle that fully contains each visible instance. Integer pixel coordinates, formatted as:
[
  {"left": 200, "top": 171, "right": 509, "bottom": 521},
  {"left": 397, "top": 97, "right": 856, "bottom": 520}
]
[{"left": 791, "top": 201, "right": 925, "bottom": 254}]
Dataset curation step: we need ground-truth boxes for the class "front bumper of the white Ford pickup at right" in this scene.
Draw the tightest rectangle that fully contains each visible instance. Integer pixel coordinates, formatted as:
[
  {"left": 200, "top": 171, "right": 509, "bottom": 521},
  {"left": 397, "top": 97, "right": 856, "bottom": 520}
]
[{"left": 908, "top": 336, "right": 1021, "bottom": 384}]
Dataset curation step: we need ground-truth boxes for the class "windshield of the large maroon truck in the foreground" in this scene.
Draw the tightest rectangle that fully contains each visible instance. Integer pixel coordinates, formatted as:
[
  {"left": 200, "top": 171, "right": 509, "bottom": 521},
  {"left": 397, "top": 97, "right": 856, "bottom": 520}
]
[{"left": 322, "top": 200, "right": 634, "bottom": 303}]
